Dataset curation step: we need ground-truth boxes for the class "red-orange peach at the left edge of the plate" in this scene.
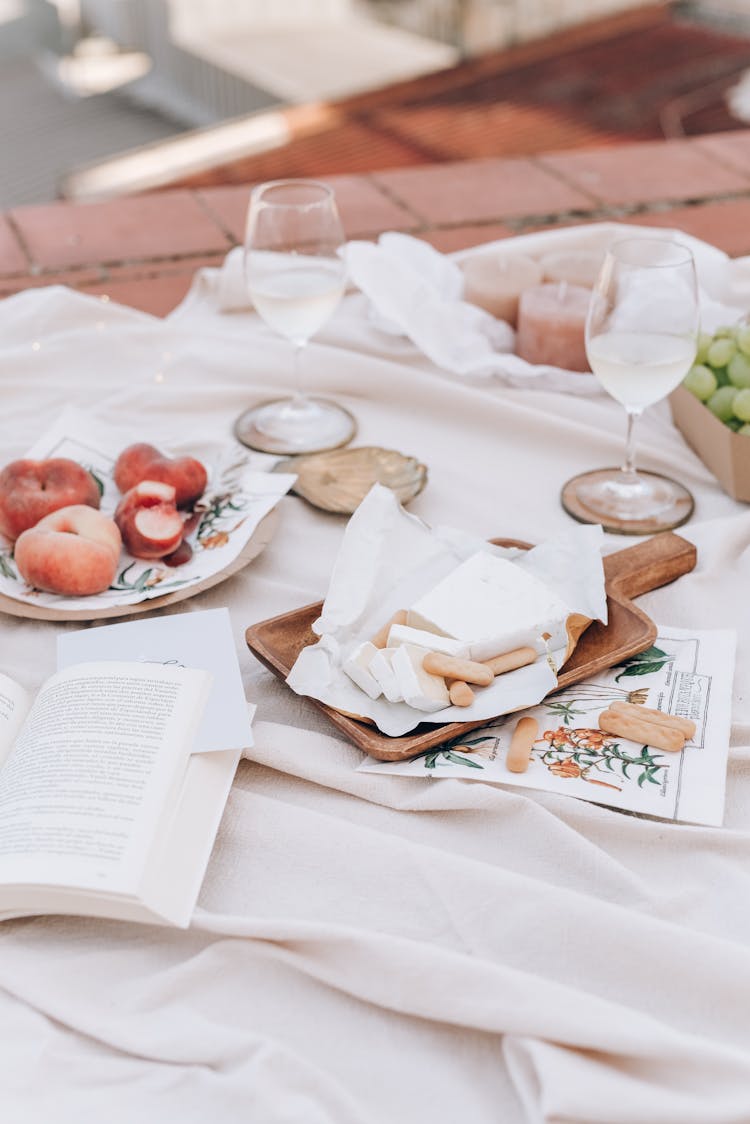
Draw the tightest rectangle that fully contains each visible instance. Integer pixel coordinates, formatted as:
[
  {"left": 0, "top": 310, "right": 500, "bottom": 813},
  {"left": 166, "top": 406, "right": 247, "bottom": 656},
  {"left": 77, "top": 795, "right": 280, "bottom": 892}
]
[{"left": 0, "top": 456, "right": 99, "bottom": 542}]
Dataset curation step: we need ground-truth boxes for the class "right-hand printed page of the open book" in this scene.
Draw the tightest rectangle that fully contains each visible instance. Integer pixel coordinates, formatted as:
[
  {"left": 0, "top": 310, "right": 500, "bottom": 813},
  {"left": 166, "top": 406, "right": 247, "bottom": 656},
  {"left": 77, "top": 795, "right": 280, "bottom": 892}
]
[{"left": 0, "top": 662, "right": 210, "bottom": 894}]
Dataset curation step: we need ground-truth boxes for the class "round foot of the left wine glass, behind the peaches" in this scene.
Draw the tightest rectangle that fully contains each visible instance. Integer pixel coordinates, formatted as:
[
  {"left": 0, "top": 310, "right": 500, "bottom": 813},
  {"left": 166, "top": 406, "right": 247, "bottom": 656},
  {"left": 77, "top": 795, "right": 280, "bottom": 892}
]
[{"left": 234, "top": 398, "right": 356, "bottom": 456}]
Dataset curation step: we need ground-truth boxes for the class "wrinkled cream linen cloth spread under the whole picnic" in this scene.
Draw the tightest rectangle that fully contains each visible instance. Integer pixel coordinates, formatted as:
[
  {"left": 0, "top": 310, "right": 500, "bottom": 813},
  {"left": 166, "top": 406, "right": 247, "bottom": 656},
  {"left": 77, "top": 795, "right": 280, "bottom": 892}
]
[{"left": 0, "top": 232, "right": 750, "bottom": 1124}]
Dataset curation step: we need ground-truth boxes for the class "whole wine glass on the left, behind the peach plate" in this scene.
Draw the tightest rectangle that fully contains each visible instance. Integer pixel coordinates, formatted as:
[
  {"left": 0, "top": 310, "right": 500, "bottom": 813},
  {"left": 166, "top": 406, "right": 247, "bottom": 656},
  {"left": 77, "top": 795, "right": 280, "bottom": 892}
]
[{"left": 234, "top": 180, "right": 356, "bottom": 454}]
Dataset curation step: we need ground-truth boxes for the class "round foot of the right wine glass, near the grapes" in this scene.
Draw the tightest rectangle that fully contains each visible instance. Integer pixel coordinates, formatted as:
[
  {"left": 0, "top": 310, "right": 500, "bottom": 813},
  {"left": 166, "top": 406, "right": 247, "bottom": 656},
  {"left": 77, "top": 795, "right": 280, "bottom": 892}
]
[{"left": 560, "top": 469, "right": 695, "bottom": 535}]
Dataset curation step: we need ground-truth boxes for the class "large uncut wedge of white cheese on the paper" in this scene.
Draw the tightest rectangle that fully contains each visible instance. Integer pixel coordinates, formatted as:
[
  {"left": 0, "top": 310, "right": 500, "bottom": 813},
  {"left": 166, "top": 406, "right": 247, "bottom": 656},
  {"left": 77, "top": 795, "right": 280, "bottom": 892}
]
[{"left": 408, "top": 551, "right": 570, "bottom": 660}]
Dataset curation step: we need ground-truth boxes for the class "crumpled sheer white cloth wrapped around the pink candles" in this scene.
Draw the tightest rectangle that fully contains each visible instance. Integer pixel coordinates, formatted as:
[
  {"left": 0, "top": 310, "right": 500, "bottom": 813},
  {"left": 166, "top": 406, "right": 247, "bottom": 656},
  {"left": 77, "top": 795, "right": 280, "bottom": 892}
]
[{"left": 178, "top": 223, "right": 750, "bottom": 395}]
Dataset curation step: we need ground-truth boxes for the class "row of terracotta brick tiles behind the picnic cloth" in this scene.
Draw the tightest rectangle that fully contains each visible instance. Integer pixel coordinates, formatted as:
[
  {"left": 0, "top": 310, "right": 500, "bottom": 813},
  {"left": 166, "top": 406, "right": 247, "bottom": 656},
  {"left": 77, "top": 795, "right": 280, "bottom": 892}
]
[{"left": 0, "top": 129, "right": 750, "bottom": 316}]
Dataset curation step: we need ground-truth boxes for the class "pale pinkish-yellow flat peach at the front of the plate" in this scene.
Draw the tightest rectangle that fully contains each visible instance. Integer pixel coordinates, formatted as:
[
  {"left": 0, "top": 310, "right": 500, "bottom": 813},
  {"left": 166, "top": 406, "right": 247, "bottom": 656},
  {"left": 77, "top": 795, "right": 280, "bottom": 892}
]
[{"left": 13, "top": 504, "right": 121, "bottom": 597}]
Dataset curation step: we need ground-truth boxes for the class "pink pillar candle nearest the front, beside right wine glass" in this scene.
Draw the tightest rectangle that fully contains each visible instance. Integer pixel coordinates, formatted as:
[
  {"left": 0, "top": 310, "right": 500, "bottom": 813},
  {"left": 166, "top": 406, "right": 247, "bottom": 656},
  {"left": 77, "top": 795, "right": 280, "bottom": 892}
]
[{"left": 516, "top": 281, "right": 591, "bottom": 371}]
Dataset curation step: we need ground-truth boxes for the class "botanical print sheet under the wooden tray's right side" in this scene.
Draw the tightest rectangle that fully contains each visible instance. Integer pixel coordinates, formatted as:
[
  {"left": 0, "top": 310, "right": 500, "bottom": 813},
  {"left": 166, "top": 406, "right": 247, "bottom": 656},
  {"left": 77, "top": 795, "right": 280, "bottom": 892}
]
[{"left": 360, "top": 628, "right": 735, "bottom": 825}]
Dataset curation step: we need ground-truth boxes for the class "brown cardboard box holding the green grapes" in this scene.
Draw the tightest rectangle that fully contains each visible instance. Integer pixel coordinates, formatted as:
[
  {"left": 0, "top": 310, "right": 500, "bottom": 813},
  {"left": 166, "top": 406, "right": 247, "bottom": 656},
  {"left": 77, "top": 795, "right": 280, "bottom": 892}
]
[{"left": 669, "top": 387, "right": 750, "bottom": 504}]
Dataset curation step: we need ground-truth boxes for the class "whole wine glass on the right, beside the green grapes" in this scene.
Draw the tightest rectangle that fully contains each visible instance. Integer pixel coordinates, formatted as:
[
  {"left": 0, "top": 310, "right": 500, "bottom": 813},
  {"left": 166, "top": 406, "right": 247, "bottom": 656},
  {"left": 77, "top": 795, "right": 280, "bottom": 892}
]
[{"left": 561, "top": 237, "right": 699, "bottom": 535}]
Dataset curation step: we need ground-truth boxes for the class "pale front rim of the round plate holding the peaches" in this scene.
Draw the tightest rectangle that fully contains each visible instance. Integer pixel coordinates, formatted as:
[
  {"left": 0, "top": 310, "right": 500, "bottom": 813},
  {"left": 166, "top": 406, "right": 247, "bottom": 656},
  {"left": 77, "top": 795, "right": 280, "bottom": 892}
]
[{"left": 0, "top": 508, "right": 279, "bottom": 620}]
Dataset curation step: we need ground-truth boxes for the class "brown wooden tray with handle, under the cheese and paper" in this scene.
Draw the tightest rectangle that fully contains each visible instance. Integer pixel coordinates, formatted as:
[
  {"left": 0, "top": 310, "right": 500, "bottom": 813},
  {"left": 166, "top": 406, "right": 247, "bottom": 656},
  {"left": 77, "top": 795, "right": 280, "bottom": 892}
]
[{"left": 245, "top": 533, "right": 696, "bottom": 761}]
